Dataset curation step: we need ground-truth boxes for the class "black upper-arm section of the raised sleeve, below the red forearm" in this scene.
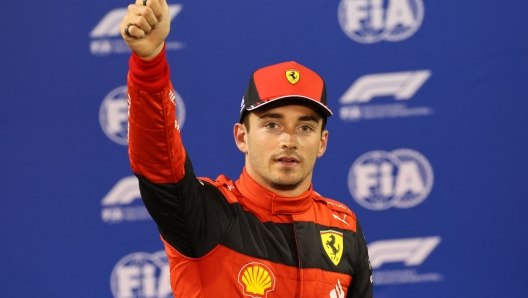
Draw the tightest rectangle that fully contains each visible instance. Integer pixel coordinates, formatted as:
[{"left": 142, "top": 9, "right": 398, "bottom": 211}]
[{"left": 136, "top": 151, "right": 233, "bottom": 258}]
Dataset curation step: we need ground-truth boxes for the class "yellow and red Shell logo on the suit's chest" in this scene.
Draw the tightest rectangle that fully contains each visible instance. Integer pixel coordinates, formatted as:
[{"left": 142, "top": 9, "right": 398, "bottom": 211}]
[{"left": 238, "top": 262, "right": 275, "bottom": 298}]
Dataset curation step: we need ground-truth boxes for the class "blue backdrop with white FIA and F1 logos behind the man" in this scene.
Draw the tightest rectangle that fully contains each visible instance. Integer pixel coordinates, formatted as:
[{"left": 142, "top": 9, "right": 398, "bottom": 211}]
[{"left": 0, "top": 0, "right": 528, "bottom": 298}]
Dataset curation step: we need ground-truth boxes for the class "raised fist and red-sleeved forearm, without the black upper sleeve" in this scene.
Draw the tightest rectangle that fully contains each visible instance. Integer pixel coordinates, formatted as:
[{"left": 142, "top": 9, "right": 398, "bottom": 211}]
[{"left": 121, "top": 0, "right": 186, "bottom": 183}]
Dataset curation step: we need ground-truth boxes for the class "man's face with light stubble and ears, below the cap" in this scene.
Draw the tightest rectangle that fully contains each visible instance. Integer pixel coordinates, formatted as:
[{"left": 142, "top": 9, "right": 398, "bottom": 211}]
[{"left": 235, "top": 105, "right": 328, "bottom": 194}]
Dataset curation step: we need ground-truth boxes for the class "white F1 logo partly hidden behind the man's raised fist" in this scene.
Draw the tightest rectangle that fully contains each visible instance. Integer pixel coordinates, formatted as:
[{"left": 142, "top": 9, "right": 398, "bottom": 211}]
[{"left": 90, "top": 4, "right": 185, "bottom": 56}]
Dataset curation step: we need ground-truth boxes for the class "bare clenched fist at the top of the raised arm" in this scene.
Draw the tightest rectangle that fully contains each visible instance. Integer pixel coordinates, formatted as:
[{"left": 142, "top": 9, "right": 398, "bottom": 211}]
[{"left": 120, "top": 0, "right": 170, "bottom": 59}]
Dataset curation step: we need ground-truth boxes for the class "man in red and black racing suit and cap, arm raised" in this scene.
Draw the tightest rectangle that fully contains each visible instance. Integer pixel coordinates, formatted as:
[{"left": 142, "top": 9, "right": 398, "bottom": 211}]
[{"left": 121, "top": 0, "right": 372, "bottom": 298}]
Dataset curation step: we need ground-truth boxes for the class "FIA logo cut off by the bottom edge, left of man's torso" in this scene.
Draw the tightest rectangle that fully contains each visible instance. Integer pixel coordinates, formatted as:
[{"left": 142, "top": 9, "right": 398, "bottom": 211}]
[{"left": 110, "top": 251, "right": 172, "bottom": 298}]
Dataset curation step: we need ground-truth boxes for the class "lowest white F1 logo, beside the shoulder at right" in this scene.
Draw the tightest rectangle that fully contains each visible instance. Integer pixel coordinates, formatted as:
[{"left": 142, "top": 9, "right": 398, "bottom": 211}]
[{"left": 368, "top": 236, "right": 441, "bottom": 269}]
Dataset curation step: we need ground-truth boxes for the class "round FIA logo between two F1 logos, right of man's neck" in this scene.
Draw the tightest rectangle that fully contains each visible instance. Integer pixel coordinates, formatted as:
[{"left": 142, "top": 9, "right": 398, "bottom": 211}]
[{"left": 348, "top": 149, "right": 434, "bottom": 211}]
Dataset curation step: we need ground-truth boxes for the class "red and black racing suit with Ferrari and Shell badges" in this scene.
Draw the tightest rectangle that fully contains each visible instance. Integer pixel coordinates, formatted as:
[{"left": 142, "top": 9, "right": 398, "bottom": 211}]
[{"left": 128, "top": 45, "right": 372, "bottom": 298}]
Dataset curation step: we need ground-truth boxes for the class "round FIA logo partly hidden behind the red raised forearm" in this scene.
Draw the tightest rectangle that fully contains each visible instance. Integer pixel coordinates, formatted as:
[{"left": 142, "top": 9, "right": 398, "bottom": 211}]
[{"left": 99, "top": 86, "right": 186, "bottom": 146}]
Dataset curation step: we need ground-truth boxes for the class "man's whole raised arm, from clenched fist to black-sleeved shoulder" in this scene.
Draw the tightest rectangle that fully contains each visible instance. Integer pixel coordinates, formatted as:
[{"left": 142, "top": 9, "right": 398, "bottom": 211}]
[{"left": 121, "top": 0, "right": 231, "bottom": 257}]
